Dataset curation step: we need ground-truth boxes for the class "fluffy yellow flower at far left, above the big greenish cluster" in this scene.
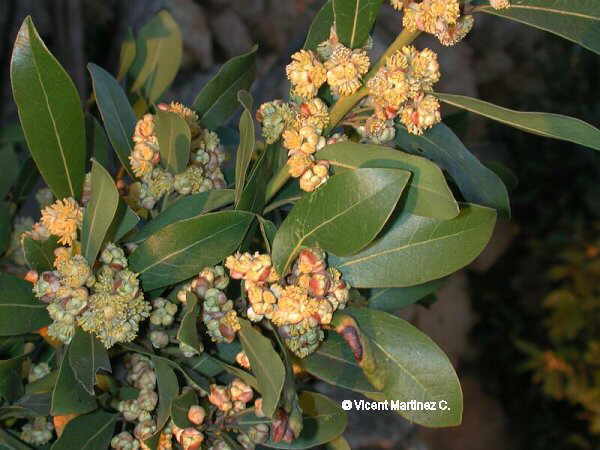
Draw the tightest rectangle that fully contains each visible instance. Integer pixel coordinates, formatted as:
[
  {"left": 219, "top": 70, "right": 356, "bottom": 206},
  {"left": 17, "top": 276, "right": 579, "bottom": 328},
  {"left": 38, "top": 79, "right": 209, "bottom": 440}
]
[{"left": 41, "top": 197, "right": 83, "bottom": 245}]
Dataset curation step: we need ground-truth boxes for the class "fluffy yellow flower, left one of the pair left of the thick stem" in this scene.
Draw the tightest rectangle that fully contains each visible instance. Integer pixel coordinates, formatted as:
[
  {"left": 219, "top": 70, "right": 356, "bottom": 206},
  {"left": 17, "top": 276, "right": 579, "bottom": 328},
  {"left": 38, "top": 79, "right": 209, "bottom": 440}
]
[{"left": 286, "top": 50, "right": 327, "bottom": 100}]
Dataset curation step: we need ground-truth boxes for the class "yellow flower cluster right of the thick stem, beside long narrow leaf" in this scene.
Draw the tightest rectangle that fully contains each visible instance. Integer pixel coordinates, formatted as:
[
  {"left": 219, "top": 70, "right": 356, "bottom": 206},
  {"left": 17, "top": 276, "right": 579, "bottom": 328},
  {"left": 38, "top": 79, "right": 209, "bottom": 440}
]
[{"left": 367, "top": 46, "right": 441, "bottom": 136}]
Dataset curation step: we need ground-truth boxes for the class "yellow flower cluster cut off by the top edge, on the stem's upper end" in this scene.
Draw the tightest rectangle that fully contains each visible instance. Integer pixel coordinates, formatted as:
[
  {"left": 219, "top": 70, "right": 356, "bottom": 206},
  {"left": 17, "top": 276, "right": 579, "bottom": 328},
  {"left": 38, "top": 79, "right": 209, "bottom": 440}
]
[{"left": 391, "top": 0, "right": 476, "bottom": 46}]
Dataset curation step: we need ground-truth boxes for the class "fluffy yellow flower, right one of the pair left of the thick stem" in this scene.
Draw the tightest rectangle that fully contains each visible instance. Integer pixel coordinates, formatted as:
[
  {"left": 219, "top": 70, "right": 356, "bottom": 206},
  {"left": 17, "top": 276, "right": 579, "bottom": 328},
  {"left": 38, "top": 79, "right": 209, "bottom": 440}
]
[{"left": 325, "top": 44, "right": 371, "bottom": 96}]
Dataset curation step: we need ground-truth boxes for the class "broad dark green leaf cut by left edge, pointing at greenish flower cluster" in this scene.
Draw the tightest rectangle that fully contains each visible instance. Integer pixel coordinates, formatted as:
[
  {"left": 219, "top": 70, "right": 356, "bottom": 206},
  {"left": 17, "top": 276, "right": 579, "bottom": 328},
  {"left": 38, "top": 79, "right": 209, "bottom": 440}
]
[{"left": 0, "top": 273, "right": 52, "bottom": 336}]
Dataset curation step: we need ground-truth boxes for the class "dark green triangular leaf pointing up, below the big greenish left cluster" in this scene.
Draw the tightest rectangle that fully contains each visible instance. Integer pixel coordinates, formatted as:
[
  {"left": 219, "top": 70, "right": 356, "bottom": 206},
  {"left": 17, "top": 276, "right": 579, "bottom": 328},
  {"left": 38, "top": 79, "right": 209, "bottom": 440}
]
[{"left": 51, "top": 349, "right": 97, "bottom": 416}]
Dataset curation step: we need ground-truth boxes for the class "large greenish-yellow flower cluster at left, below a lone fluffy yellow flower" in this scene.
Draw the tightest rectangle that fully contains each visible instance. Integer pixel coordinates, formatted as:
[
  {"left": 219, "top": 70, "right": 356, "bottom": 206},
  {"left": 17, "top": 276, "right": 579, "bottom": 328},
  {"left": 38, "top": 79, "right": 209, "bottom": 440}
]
[{"left": 29, "top": 243, "right": 150, "bottom": 348}]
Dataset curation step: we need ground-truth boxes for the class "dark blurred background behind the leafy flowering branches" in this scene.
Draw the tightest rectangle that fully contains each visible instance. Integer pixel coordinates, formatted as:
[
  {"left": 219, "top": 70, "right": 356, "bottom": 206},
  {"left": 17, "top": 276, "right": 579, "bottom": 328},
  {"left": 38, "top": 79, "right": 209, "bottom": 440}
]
[{"left": 0, "top": 0, "right": 600, "bottom": 450}]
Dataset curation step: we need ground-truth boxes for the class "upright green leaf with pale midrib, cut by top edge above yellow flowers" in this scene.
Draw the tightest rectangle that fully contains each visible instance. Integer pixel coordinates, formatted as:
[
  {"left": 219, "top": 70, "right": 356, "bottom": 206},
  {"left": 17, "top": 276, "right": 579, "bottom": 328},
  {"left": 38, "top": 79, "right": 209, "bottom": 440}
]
[{"left": 333, "top": 0, "right": 383, "bottom": 48}]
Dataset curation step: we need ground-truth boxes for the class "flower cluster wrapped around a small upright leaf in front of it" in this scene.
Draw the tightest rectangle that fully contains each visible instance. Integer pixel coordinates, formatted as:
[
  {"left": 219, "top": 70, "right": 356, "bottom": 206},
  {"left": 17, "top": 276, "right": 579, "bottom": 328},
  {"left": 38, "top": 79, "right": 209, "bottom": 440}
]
[{"left": 129, "top": 102, "right": 225, "bottom": 210}]
